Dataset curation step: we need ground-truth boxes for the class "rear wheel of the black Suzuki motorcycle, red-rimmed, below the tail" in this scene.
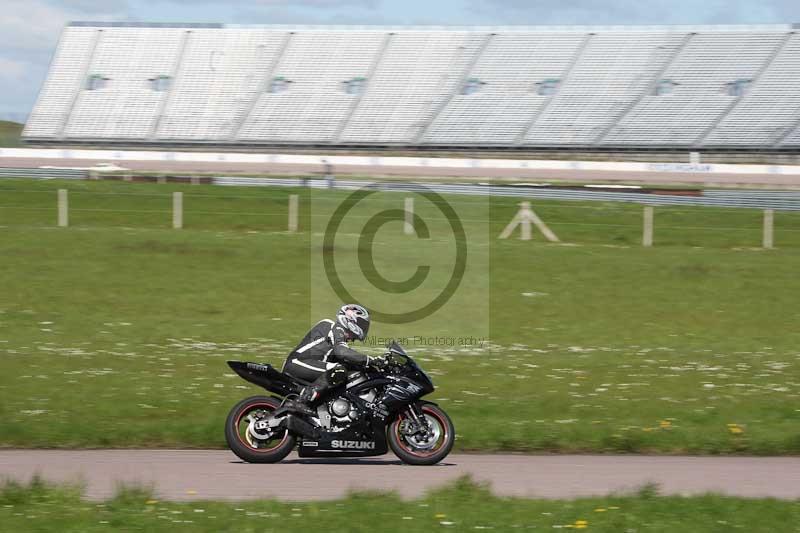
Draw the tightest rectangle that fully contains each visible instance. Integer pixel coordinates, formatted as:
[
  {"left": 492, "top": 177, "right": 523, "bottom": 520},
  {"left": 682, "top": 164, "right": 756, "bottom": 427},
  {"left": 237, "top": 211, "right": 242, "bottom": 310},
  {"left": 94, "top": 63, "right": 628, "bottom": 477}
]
[{"left": 225, "top": 396, "right": 296, "bottom": 463}]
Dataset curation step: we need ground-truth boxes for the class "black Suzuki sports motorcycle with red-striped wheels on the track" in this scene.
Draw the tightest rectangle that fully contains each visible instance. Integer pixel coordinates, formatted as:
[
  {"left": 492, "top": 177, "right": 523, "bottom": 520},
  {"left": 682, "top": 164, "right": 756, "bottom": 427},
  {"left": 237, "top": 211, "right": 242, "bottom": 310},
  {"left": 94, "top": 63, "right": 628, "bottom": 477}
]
[{"left": 225, "top": 342, "right": 455, "bottom": 465}]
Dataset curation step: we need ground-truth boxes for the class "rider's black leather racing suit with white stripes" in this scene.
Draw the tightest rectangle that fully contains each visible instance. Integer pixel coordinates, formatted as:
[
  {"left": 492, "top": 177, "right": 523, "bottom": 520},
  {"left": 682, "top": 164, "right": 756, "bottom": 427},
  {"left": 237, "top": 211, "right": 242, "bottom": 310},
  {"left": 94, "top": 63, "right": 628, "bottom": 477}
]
[{"left": 283, "top": 320, "right": 370, "bottom": 396}]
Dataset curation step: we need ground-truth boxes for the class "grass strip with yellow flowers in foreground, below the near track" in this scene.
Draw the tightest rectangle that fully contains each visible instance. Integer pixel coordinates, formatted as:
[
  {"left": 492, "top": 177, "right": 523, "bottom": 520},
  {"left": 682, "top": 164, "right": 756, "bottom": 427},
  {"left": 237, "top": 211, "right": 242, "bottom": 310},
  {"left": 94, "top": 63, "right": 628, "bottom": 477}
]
[{"left": 0, "top": 479, "right": 800, "bottom": 533}]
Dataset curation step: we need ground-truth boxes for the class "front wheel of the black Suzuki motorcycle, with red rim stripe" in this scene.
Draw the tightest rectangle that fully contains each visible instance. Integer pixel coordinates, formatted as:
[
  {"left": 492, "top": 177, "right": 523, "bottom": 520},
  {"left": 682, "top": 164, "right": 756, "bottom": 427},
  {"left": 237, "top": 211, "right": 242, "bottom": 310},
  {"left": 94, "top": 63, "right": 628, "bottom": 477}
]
[{"left": 387, "top": 403, "right": 456, "bottom": 465}]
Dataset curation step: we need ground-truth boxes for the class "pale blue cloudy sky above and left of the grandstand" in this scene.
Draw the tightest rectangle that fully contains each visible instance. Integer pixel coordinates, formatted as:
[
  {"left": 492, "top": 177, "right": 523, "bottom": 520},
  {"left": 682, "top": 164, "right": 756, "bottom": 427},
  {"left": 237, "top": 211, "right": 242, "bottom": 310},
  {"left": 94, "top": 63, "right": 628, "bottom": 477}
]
[{"left": 0, "top": 0, "right": 800, "bottom": 122}]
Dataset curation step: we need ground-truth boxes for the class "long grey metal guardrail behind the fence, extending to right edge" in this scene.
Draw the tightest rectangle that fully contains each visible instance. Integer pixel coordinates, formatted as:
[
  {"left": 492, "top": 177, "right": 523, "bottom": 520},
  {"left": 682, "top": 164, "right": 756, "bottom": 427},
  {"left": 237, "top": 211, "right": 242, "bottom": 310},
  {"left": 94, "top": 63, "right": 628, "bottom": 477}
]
[{"left": 213, "top": 177, "right": 800, "bottom": 211}]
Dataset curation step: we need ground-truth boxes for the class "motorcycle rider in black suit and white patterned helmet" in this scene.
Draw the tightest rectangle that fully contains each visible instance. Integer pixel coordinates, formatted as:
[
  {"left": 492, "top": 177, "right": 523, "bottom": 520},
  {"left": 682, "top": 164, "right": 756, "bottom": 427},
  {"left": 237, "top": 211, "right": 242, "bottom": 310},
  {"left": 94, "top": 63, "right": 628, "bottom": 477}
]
[{"left": 283, "top": 304, "right": 385, "bottom": 416}]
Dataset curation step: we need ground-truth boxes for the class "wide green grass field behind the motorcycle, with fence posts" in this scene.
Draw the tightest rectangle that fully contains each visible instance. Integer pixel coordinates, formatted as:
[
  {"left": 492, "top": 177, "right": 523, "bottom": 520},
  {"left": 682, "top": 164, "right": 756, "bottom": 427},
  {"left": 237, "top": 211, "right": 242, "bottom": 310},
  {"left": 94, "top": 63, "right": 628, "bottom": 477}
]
[{"left": 0, "top": 181, "right": 800, "bottom": 454}]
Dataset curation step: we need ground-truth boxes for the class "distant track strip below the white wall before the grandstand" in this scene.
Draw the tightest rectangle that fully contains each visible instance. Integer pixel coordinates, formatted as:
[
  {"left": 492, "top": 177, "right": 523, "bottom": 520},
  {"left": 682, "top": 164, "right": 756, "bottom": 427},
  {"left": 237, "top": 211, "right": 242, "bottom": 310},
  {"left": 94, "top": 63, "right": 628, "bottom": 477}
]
[{"left": 2, "top": 157, "right": 800, "bottom": 188}]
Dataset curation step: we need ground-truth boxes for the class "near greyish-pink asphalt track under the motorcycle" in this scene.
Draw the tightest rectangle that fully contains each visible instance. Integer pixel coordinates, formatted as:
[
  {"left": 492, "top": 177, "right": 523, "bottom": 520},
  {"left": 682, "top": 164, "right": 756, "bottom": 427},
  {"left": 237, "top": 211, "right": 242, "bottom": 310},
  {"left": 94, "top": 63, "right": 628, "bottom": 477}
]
[{"left": 0, "top": 450, "right": 800, "bottom": 501}]
